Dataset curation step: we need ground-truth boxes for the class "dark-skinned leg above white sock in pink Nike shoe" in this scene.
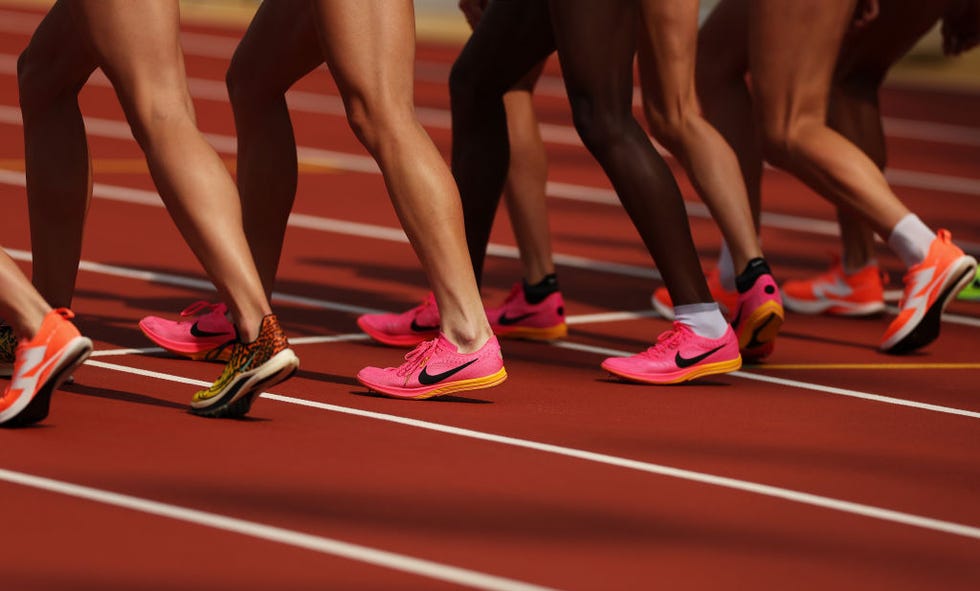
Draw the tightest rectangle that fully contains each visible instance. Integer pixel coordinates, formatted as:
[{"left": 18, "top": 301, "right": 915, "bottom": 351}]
[{"left": 549, "top": 0, "right": 712, "bottom": 305}]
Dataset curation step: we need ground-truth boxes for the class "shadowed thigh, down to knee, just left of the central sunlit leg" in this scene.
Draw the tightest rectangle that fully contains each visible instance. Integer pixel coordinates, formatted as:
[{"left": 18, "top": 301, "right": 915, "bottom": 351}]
[{"left": 228, "top": 0, "right": 323, "bottom": 93}]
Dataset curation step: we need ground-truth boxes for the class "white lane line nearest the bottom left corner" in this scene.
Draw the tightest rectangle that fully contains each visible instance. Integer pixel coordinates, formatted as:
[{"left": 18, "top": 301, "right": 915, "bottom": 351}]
[{"left": 0, "top": 468, "right": 548, "bottom": 591}]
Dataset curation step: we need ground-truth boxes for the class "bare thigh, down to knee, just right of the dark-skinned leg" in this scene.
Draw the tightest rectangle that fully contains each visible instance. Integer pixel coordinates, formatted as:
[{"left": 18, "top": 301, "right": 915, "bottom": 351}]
[{"left": 637, "top": 0, "right": 698, "bottom": 113}]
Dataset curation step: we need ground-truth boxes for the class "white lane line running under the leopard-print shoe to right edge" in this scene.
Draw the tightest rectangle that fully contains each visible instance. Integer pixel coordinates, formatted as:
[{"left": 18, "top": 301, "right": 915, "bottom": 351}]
[{"left": 65, "top": 360, "right": 980, "bottom": 540}]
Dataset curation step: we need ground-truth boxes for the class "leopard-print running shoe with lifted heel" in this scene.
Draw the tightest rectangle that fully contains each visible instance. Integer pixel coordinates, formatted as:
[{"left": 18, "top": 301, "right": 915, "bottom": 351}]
[{"left": 191, "top": 314, "right": 299, "bottom": 418}]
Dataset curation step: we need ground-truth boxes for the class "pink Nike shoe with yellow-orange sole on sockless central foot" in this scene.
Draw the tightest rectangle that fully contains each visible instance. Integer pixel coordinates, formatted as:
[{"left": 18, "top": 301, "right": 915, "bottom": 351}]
[{"left": 357, "top": 333, "right": 507, "bottom": 400}]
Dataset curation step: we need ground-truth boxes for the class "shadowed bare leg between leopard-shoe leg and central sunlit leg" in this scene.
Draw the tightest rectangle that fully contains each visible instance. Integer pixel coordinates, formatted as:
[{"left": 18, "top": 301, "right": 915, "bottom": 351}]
[{"left": 227, "top": 0, "right": 323, "bottom": 298}]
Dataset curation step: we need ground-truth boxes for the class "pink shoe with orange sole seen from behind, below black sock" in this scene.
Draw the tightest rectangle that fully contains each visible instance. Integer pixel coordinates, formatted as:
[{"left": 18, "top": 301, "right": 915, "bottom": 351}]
[{"left": 732, "top": 273, "right": 786, "bottom": 361}]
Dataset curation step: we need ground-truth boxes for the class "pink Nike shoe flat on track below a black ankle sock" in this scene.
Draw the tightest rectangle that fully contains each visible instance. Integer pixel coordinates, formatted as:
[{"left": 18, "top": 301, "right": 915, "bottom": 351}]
[{"left": 486, "top": 281, "right": 568, "bottom": 341}]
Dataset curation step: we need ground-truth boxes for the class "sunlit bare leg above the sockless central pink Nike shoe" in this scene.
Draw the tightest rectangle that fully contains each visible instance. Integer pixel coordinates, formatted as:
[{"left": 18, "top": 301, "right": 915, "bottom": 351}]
[{"left": 316, "top": 0, "right": 491, "bottom": 353}]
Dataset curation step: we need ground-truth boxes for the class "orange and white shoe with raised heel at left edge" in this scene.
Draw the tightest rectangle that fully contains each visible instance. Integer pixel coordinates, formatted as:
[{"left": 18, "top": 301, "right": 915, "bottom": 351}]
[{"left": 0, "top": 308, "right": 92, "bottom": 426}]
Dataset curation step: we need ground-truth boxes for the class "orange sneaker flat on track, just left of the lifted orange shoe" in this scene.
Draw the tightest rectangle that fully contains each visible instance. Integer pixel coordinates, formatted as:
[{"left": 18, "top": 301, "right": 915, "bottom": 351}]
[{"left": 783, "top": 256, "right": 885, "bottom": 316}]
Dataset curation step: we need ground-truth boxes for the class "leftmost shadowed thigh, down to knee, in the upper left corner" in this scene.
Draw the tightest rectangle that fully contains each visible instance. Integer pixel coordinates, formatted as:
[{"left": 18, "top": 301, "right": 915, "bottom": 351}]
[{"left": 20, "top": 0, "right": 98, "bottom": 98}]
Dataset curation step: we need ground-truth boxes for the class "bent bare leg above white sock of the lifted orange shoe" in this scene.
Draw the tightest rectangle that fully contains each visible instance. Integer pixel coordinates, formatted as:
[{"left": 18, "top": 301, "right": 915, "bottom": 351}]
[{"left": 749, "top": 0, "right": 909, "bottom": 237}]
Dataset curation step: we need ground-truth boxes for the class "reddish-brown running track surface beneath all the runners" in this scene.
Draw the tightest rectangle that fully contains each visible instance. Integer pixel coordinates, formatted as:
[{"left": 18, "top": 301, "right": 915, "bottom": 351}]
[{"left": 0, "top": 5, "right": 980, "bottom": 590}]
